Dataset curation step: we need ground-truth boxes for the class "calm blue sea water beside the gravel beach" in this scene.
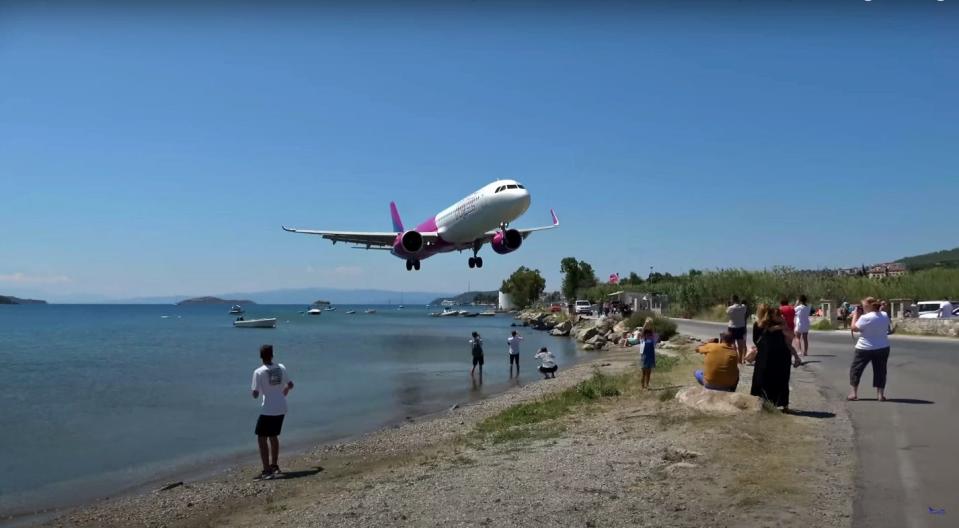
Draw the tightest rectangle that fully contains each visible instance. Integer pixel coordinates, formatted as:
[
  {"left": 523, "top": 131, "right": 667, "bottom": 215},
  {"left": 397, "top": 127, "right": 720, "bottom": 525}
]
[{"left": 0, "top": 305, "right": 581, "bottom": 519}]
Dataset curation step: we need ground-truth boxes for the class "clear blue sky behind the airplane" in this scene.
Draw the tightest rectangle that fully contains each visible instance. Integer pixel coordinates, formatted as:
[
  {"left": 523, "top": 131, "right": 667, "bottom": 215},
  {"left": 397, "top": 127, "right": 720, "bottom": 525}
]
[{"left": 0, "top": 0, "right": 959, "bottom": 299}]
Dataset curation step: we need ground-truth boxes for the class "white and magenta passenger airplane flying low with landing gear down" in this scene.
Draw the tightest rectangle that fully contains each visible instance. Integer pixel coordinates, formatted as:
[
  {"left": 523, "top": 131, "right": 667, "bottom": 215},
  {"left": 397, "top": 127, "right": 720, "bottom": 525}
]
[{"left": 282, "top": 180, "right": 559, "bottom": 271}]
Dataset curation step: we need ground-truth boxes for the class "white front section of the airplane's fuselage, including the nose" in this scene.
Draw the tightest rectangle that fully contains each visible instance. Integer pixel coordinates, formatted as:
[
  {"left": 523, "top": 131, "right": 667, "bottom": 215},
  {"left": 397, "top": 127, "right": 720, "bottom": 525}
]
[{"left": 435, "top": 180, "right": 530, "bottom": 245}]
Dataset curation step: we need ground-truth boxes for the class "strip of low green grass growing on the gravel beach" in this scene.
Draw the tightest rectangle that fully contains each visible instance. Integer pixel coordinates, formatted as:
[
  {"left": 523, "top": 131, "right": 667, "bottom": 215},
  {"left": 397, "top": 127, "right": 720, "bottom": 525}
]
[{"left": 474, "top": 369, "right": 631, "bottom": 443}]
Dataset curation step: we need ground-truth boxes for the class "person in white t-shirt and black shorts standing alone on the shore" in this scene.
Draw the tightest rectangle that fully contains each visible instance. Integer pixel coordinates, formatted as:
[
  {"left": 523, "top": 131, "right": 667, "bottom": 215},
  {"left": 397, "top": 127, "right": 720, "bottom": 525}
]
[{"left": 251, "top": 345, "right": 293, "bottom": 479}]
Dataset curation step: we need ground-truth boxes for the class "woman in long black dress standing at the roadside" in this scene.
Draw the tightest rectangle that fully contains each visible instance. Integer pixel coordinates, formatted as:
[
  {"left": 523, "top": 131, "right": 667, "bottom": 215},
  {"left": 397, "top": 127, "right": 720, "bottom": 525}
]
[{"left": 749, "top": 304, "right": 802, "bottom": 410}]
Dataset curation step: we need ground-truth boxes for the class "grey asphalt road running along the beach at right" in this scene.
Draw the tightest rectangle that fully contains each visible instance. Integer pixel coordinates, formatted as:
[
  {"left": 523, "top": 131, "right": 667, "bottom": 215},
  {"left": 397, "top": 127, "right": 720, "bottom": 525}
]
[{"left": 676, "top": 320, "right": 959, "bottom": 528}]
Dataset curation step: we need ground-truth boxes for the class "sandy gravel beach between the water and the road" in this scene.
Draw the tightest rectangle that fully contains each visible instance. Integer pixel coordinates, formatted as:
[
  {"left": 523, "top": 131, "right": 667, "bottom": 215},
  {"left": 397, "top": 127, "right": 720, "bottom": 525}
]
[{"left": 47, "top": 338, "right": 855, "bottom": 527}]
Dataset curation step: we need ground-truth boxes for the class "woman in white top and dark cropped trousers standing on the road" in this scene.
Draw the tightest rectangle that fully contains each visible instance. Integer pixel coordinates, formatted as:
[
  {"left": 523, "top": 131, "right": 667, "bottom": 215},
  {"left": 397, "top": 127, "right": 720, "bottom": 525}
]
[{"left": 847, "top": 297, "right": 889, "bottom": 401}]
